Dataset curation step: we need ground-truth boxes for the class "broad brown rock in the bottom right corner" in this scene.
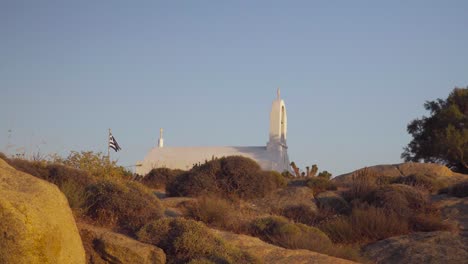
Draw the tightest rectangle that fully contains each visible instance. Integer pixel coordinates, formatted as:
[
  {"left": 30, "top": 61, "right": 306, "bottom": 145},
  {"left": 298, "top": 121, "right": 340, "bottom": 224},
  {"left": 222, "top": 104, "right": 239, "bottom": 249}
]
[{"left": 363, "top": 231, "right": 468, "bottom": 264}]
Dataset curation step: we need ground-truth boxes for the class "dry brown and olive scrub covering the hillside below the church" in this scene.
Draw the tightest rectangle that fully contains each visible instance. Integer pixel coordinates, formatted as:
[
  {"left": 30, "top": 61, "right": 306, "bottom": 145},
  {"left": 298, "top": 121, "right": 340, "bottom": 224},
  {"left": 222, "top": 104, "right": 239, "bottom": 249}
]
[{"left": 1, "top": 152, "right": 467, "bottom": 263}]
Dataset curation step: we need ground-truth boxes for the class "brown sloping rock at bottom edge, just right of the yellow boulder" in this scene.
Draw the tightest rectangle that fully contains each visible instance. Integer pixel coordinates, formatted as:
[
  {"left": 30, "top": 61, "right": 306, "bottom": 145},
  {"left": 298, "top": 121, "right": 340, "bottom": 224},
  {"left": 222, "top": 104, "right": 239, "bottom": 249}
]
[{"left": 78, "top": 223, "right": 166, "bottom": 264}]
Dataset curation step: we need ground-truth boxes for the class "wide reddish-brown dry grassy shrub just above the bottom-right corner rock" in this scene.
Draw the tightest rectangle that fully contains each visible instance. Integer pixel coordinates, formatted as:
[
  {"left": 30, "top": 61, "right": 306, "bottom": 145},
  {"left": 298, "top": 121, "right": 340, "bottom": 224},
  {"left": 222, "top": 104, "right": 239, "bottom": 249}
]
[{"left": 319, "top": 205, "right": 409, "bottom": 244}]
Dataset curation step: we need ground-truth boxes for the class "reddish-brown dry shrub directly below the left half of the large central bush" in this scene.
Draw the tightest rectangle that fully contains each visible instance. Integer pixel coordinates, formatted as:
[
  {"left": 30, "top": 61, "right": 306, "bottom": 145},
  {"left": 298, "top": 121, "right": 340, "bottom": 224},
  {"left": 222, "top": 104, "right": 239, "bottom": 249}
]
[{"left": 186, "top": 196, "right": 242, "bottom": 232}]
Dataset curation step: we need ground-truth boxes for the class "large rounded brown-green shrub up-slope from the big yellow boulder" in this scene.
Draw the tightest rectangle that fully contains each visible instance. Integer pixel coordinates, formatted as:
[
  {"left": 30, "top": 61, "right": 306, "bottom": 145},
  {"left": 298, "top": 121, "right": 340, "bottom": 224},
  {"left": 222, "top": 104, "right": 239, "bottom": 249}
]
[{"left": 85, "top": 180, "right": 163, "bottom": 234}]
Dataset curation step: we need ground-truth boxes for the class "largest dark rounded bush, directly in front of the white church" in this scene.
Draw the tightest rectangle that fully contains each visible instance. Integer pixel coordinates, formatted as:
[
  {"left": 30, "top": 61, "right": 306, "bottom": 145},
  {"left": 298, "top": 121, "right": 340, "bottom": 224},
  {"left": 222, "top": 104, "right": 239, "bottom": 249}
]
[{"left": 166, "top": 156, "right": 286, "bottom": 199}]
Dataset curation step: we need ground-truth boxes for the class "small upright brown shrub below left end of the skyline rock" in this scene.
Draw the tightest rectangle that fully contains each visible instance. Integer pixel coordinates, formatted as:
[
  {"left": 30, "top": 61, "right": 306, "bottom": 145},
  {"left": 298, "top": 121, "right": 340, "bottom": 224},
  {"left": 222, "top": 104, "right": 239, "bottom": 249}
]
[{"left": 343, "top": 168, "right": 378, "bottom": 201}]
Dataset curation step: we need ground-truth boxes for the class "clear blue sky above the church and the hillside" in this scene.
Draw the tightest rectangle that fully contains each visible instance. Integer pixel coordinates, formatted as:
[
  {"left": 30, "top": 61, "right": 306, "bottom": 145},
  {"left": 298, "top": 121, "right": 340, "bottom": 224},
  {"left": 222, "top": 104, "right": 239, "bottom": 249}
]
[{"left": 0, "top": 0, "right": 468, "bottom": 175}]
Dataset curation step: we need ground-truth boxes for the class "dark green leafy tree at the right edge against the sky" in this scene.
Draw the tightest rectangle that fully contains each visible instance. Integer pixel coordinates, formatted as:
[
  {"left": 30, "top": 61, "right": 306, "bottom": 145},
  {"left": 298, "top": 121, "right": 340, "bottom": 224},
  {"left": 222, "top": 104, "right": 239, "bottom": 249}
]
[{"left": 401, "top": 87, "right": 468, "bottom": 173}]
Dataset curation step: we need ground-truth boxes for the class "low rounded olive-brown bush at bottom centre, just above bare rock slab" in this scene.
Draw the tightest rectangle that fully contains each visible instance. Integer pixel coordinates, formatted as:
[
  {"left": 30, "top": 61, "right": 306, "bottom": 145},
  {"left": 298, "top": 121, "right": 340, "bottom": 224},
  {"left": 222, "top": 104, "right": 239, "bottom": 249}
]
[{"left": 250, "top": 216, "right": 331, "bottom": 252}]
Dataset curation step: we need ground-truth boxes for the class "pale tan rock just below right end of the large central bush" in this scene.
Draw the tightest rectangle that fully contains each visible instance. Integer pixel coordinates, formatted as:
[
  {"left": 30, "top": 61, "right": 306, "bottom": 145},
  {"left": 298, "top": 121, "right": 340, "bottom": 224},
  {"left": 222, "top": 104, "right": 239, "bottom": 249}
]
[{"left": 252, "top": 186, "right": 317, "bottom": 213}]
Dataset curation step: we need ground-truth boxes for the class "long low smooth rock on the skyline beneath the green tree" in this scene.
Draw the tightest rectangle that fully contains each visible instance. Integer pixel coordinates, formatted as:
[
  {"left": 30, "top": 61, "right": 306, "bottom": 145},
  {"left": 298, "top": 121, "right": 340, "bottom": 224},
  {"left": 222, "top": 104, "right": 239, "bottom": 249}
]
[{"left": 333, "top": 162, "right": 468, "bottom": 184}]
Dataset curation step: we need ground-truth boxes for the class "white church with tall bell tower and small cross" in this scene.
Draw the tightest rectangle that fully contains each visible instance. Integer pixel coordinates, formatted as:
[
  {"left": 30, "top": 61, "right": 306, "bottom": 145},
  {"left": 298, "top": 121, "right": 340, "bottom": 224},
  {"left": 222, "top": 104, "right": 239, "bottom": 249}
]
[{"left": 136, "top": 88, "right": 290, "bottom": 175}]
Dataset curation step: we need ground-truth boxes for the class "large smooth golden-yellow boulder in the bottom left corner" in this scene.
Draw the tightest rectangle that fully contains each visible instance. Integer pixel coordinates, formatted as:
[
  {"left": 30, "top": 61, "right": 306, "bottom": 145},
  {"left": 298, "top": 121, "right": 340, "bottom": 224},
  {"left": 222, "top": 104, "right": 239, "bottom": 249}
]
[{"left": 0, "top": 159, "right": 86, "bottom": 264}]
